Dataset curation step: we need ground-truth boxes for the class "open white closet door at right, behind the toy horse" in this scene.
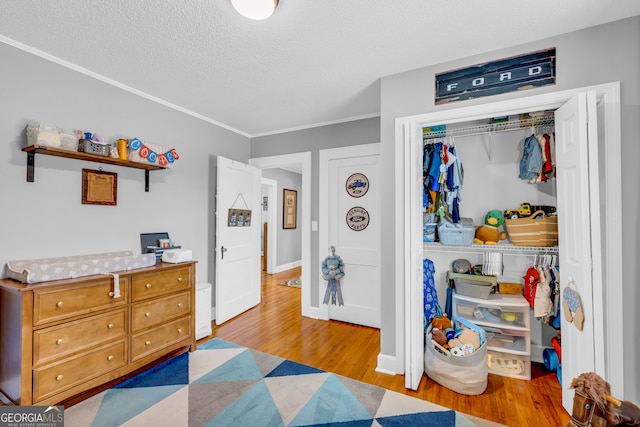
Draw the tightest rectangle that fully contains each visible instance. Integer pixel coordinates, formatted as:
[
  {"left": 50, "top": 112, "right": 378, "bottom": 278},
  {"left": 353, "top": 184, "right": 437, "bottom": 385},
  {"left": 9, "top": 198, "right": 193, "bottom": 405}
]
[{"left": 555, "top": 92, "right": 604, "bottom": 413}]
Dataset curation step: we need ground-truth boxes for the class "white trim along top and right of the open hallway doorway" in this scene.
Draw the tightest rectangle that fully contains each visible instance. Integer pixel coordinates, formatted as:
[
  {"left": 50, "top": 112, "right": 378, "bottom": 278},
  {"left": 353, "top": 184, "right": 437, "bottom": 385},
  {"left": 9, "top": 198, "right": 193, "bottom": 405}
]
[{"left": 249, "top": 151, "right": 318, "bottom": 318}]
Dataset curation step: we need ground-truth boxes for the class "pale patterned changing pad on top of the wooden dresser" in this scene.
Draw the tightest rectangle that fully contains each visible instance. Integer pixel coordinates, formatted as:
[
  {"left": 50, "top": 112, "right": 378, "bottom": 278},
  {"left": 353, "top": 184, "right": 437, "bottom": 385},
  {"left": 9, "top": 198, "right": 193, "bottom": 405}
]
[{"left": 7, "top": 251, "right": 156, "bottom": 283}]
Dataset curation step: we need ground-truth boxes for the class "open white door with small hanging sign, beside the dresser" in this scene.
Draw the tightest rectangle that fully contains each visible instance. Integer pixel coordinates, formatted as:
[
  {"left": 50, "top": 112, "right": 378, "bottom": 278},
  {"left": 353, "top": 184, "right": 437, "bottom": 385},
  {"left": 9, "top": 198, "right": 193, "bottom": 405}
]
[{"left": 215, "top": 156, "right": 262, "bottom": 325}]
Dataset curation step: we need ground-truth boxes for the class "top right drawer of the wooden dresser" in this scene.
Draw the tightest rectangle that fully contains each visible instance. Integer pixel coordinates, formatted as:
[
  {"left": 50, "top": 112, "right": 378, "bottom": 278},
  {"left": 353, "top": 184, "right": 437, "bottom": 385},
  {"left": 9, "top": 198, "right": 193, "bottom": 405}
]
[{"left": 132, "top": 267, "right": 191, "bottom": 301}]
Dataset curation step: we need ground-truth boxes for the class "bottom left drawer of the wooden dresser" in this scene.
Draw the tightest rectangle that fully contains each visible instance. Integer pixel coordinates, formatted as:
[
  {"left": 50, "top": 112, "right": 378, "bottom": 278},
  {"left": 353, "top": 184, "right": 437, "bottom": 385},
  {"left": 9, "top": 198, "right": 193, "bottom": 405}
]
[{"left": 33, "top": 339, "right": 127, "bottom": 402}]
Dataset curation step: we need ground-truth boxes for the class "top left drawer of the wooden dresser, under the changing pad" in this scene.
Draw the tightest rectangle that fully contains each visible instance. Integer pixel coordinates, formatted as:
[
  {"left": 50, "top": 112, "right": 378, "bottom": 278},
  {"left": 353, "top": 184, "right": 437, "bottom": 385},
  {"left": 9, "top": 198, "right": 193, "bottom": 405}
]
[{"left": 33, "top": 276, "right": 128, "bottom": 326}]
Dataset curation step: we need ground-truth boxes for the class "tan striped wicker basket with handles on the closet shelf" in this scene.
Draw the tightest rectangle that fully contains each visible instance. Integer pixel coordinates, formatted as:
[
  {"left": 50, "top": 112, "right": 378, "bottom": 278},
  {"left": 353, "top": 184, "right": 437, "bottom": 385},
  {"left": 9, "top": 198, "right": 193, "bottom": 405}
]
[{"left": 504, "top": 211, "right": 558, "bottom": 246}]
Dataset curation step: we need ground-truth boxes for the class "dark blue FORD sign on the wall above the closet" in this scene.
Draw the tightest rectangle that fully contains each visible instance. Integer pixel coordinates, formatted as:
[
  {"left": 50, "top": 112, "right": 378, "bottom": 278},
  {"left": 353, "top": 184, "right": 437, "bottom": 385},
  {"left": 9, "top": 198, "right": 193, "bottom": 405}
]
[{"left": 436, "top": 47, "right": 556, "bottom": 105}]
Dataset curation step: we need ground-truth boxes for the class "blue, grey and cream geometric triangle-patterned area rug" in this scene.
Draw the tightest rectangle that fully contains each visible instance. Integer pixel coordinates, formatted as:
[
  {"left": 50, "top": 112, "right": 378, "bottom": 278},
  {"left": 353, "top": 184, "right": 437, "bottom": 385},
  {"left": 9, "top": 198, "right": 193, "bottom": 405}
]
[{"left": 64, "top": 338, "right": 492, "bottom": 427}]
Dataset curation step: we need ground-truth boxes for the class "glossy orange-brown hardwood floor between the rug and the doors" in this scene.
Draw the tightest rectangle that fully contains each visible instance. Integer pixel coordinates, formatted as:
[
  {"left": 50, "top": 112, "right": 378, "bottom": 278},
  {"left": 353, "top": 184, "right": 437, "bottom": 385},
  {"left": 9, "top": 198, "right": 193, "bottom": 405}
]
[{"left": 212, "top": 268, "right": 570, "bottom": 426}]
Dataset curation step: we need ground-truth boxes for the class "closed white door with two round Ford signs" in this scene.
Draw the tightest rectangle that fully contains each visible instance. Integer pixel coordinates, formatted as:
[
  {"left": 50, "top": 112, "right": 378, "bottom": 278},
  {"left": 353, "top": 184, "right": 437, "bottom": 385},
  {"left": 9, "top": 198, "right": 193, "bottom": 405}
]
[{"left": 319, "top": 144, "right": 380, "bottom": 328}]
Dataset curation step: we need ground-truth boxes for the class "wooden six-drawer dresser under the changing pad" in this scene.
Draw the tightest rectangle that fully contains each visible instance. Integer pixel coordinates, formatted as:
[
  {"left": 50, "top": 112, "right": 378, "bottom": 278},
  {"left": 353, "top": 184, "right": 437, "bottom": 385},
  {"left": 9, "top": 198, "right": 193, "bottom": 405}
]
[{"left": 0, "top": 262, "right": 196, "bottom": 405}]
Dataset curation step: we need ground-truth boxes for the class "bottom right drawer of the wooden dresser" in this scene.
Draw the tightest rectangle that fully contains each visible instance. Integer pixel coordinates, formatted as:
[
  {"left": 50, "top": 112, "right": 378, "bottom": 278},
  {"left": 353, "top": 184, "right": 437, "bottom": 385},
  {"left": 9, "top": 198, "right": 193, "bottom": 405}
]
[{"left": 131, "top": 316, "right": 192, "bottom": 362}]
